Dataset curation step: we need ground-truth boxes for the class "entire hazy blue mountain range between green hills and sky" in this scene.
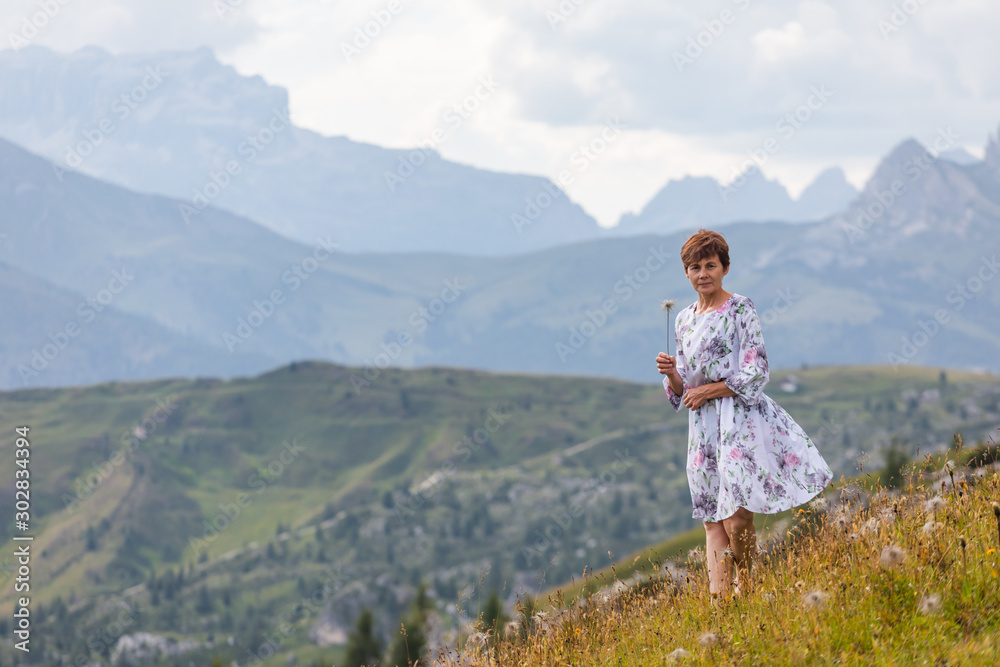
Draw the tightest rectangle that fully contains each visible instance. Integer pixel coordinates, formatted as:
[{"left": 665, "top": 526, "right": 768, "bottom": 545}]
[{"left": 0, "top": 47, "right": 1000, "bottom": 388}]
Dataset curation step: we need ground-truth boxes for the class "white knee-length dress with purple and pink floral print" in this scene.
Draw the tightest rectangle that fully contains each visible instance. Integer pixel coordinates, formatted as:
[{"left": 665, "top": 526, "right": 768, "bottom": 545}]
[{"left": 663, "top": 293, "right": 833, "bottom": 521}]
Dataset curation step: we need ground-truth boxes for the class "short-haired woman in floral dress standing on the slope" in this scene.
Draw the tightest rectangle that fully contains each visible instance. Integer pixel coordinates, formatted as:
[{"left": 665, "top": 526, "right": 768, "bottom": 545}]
[{"left": 656, "top": 229, "right": 833, "bottom": 597}]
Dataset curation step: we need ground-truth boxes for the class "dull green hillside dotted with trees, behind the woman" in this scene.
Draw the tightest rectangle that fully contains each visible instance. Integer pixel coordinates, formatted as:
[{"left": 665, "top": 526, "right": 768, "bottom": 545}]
[{"left": 0, "top": 363, "right": 1000, "bottom": 665}]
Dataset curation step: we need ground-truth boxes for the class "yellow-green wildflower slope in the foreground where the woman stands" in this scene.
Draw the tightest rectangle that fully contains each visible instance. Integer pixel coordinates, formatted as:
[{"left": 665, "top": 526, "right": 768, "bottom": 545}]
[{"left": 454, "top": 442, "right": 1000, "bottom": 666}]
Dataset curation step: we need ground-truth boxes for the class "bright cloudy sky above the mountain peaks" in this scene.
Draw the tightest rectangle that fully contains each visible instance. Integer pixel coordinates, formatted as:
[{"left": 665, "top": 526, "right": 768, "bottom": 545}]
[{"left": 0, "top": 0, "right": 1000, "bottom": 226}]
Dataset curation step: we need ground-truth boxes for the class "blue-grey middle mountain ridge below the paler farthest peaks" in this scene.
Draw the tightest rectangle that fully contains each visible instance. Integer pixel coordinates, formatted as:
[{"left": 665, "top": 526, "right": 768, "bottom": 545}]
[{"left": 0, "top": 125, "right": 1000, "bottom": 386}]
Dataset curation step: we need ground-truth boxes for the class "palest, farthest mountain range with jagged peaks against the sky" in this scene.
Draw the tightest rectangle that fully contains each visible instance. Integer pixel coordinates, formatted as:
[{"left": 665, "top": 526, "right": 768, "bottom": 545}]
[{"left": 0, "top": 46, "right": 892, "bottom": 256}]
